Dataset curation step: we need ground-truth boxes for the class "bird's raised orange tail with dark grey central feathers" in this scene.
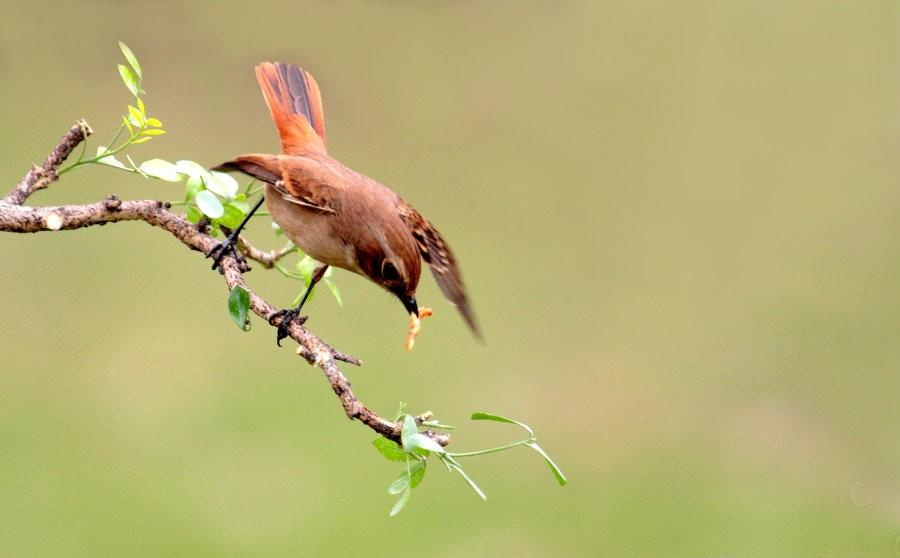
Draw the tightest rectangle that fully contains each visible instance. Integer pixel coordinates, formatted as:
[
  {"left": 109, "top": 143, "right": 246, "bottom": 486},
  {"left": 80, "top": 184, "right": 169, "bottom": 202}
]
[{"left": 256, "top": 62, "right": 325, "bottom": 155}]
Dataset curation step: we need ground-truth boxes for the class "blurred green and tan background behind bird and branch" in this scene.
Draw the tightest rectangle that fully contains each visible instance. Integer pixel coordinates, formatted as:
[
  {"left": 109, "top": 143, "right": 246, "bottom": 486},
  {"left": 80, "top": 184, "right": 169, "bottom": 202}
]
[{"left": 0, "top": 1, "right": 900, "bottom": 557}]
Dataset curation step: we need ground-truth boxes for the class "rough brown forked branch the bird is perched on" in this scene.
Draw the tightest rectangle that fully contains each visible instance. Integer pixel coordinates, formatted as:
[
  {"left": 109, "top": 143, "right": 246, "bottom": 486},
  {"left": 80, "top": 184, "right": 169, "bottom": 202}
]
[{"left": 0, "top": 120, "right": 450, "bottom": 446}]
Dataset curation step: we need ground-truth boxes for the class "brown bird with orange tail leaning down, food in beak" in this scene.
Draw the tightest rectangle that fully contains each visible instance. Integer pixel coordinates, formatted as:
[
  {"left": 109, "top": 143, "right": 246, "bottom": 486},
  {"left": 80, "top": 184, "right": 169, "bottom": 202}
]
[{"left": 209, "top": 62, "right": 480, "bottom": 349}]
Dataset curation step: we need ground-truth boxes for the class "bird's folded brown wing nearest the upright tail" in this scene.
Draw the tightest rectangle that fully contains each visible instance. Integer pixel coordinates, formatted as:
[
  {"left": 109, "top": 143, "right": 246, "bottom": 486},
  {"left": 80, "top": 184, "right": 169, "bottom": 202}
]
[{"left": 212, "top": 153, "right": 335, "bottom": 213}]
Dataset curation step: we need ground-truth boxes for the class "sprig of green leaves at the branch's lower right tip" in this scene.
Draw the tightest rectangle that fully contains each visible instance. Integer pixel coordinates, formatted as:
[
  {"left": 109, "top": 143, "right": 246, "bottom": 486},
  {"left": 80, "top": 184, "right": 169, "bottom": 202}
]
[{"left": 372, "top": 412, "right": 568, "bottom": 516}]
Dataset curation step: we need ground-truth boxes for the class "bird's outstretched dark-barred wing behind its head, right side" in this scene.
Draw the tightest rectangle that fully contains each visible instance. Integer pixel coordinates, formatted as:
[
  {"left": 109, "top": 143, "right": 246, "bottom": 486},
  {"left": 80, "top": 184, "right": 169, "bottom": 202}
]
[{"left": 398, "top": 201, "right": 481, "bottom": 338}]
